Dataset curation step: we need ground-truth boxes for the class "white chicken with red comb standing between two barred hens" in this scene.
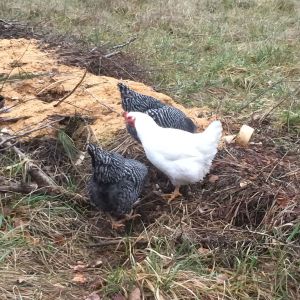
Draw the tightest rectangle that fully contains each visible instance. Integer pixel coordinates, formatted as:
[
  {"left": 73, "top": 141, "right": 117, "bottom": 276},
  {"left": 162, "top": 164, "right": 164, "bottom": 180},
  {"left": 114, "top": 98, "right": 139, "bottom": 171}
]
[{"left": 124, "top": 112, "right": 222, "bottom": 201}]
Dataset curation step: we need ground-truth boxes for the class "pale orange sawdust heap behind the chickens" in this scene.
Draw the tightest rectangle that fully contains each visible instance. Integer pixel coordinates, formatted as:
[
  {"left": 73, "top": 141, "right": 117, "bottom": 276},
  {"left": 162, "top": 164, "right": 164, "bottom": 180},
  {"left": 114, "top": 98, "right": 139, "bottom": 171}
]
[{"left": 0, "top": 39, "right": 209, "bottom": 141}]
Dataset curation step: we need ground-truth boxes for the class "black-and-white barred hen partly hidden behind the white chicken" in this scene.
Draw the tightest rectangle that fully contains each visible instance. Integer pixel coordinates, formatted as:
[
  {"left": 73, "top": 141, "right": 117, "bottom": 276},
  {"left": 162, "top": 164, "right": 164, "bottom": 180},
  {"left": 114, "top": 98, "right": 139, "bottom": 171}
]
[{"left": 118, "top": 83, "right": 197, "bottom": 142}]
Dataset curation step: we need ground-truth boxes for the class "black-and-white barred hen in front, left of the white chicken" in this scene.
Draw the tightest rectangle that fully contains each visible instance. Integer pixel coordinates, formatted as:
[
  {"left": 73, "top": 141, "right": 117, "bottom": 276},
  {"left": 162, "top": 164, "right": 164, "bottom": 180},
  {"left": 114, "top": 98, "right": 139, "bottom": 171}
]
[{"left": 87, "top": 144, "right": 148, "bottom": 228}]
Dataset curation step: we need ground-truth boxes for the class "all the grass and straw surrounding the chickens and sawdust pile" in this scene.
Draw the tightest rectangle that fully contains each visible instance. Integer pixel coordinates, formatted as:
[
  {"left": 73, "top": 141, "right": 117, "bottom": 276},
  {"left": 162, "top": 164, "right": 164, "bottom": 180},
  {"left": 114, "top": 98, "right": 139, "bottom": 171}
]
[{"left": 0, "top": 0, "right": 300, "bottom": 300}]
